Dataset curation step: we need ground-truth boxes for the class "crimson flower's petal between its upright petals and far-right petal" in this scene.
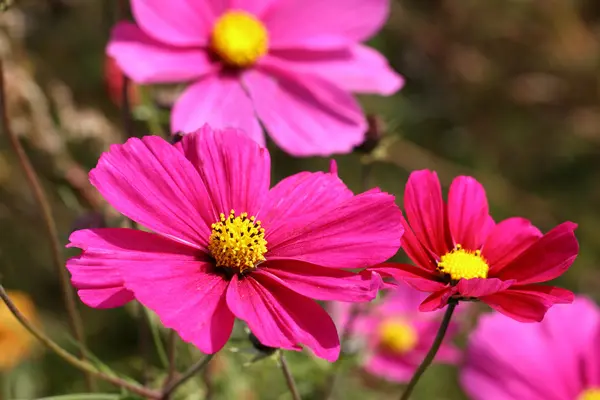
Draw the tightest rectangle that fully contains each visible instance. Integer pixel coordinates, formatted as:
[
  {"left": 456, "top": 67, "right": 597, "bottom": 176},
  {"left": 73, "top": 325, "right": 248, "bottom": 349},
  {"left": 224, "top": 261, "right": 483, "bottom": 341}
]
[{"left": 482, "top": 218, "right": 543, "bottom": 275}]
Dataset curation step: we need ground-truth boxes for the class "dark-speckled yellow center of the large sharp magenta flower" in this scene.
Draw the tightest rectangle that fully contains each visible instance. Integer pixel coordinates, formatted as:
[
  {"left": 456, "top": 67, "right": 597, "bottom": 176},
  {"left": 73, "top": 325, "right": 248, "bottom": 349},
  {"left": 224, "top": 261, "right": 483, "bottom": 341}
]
[{"left": 208, "top": 210, "right": 267, "bottom": 272}]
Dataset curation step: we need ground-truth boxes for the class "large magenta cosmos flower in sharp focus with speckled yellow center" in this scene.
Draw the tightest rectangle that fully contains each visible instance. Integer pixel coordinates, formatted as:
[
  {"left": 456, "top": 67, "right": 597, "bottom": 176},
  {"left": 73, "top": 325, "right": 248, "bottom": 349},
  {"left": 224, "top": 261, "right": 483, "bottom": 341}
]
[{"left": 67, "top": 126, "right": 402, "bottom": 361}]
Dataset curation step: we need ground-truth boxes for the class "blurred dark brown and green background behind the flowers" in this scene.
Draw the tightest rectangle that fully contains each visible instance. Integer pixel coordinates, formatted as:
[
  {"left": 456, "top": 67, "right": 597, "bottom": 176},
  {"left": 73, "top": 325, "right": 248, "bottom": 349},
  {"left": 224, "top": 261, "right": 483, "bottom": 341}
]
[{"left": 0, "top": 0, "right": 600, "bottom": 399}]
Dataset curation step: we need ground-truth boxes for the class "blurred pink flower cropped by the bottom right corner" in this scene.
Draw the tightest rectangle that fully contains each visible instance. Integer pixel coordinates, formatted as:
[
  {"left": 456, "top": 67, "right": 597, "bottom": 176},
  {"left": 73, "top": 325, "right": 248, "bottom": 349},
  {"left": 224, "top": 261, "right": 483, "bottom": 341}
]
[{"left": 460, "top": 297, "right": 600, "bottom": 400}]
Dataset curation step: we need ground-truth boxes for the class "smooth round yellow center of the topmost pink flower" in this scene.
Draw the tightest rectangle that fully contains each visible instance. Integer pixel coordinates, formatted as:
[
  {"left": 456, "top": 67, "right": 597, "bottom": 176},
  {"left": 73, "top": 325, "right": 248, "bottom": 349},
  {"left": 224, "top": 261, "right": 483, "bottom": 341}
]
[{"left": 211, "top": 11, "right": 269, "bottom": 68}]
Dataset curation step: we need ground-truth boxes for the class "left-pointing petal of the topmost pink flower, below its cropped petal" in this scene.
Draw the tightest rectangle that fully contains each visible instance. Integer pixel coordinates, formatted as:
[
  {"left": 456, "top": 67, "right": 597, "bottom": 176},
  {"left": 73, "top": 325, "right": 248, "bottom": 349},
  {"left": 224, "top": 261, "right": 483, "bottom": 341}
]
[{"left": 106, "top": 22, "right": 219, "bottom": 83}]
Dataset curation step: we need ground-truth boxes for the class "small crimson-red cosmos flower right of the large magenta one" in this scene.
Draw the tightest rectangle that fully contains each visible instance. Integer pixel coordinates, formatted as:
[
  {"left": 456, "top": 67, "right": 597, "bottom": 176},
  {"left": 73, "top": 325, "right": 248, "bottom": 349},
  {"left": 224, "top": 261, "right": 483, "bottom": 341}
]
[{"left": 373, "top": 170, "right": 579, "bottom": 322}]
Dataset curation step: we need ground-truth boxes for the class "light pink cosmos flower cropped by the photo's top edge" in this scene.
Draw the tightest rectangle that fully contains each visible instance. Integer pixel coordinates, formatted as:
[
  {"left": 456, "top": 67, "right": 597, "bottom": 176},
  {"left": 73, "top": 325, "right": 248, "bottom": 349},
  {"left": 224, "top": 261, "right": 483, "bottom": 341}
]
[{"left": 107, "top": 0, "right": 403, "bottom": 156}]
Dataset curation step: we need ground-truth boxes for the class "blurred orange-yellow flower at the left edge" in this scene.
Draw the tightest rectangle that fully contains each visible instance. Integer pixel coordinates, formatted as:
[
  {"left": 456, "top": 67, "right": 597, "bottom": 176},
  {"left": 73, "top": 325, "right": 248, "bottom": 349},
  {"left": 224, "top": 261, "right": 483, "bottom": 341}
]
[{"left": 0, "top": 291, "right": 37, "bottom": 372}]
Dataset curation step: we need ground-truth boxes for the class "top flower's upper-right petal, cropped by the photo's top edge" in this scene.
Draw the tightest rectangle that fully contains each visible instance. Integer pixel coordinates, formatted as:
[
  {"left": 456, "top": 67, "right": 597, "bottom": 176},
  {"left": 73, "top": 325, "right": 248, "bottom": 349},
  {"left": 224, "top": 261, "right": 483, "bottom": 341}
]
[{"left": 263, "top": 0, "right": 390, "bottom": 48}]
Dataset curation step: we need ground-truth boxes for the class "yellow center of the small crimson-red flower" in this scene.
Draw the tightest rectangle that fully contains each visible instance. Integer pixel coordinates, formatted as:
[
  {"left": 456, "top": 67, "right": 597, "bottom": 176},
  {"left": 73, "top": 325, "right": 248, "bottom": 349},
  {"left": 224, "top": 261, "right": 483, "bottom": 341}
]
[{"left": 438, "top": 244, "right": 490, "bottom": 281}]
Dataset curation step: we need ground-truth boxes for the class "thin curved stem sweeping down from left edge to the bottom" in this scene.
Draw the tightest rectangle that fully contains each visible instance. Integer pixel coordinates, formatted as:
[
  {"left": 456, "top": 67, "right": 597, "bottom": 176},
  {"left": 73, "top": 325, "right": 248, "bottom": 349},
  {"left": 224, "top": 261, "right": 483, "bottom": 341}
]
[{"left": 0, "top": 285, "right": 162, "bottom": 400}]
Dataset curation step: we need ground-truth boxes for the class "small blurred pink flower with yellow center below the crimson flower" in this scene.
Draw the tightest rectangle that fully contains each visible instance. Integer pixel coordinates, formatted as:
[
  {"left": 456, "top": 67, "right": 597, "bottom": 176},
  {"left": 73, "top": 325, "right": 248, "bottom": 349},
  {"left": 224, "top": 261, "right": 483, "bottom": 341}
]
[{"left": 330, "top": 285, "right": 460, "bottom": 382}]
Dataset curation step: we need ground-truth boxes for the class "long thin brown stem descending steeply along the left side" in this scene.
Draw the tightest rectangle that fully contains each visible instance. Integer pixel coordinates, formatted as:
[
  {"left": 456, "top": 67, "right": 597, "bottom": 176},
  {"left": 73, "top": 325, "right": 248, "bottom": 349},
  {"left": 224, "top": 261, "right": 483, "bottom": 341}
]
[{"left": 0, "top": 60, "right": 95, "bottom": 391}]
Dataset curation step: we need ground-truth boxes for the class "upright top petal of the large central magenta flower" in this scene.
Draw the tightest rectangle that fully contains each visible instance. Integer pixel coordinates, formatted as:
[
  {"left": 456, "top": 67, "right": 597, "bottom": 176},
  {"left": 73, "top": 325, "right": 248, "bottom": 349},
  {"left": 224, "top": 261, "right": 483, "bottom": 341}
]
[{"left": 181, "top": 125, "right": 271, "bottom": 217}]
